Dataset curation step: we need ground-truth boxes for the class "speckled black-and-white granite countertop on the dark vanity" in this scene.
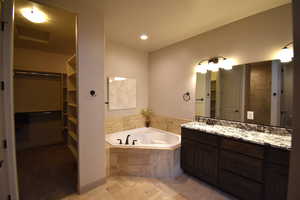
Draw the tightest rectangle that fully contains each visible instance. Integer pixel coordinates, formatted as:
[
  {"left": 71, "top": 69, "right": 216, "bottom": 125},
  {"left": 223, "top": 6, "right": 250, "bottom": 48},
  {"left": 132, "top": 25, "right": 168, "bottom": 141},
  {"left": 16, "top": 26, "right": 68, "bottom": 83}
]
[{"left": 181, "top": 122, "right": 292, "bottom": 150}]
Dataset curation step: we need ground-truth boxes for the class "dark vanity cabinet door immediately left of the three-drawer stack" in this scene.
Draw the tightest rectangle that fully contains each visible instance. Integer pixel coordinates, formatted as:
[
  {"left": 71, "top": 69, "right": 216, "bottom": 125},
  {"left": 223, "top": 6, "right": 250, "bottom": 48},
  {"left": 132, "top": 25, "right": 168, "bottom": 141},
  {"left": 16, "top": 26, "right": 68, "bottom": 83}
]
[{"left": 194, "top": 144, "right": 218, "bottom": 184}]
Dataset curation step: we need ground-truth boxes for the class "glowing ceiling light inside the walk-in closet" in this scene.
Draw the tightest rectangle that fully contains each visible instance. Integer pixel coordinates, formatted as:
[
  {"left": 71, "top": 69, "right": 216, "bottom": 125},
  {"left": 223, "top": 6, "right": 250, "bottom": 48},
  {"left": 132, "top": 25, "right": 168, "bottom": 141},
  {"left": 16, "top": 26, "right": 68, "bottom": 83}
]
[{"left": 21, "top": 7, "right": 48, "bottom": 23}]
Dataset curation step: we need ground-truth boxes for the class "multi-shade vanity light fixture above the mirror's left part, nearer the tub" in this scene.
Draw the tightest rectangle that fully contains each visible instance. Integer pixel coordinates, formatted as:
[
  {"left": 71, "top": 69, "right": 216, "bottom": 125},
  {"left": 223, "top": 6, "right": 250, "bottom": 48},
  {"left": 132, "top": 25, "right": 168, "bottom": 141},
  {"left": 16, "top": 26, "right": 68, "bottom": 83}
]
[{"left": 196, "top": 56, "right": 235, "bottom": 74}]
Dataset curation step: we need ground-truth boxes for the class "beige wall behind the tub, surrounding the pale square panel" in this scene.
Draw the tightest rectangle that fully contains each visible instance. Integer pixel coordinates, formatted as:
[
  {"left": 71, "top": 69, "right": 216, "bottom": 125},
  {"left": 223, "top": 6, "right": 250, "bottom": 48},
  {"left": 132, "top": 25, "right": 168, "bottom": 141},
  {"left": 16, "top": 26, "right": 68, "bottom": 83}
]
[{"left": 105, "top": 41, "right": 148, "bottom": 118}]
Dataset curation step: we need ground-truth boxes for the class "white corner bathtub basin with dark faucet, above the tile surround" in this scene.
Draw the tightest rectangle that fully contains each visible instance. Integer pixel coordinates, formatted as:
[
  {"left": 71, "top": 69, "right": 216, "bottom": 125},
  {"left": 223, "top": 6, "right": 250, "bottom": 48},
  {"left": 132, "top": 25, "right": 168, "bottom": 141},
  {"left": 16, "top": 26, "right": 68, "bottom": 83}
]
[{"left": 106, "top": 128, "right": 181, "bottom": 148}]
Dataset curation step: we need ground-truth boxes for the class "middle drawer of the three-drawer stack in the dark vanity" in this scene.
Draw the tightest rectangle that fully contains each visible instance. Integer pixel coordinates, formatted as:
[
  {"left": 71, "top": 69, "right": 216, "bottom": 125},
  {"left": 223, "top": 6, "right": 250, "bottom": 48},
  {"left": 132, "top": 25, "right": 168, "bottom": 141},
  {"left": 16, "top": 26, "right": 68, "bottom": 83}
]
[{"left": 220, "top": 150, "right": 263, "bottom": 182}]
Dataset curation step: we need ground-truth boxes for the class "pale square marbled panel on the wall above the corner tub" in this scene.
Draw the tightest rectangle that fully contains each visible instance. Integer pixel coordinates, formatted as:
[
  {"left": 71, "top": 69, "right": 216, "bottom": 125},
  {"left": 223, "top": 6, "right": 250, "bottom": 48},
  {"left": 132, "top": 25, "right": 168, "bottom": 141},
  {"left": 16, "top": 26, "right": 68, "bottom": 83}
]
[{"left": 107, "top": 77, "right": 136, "bottom": 110}]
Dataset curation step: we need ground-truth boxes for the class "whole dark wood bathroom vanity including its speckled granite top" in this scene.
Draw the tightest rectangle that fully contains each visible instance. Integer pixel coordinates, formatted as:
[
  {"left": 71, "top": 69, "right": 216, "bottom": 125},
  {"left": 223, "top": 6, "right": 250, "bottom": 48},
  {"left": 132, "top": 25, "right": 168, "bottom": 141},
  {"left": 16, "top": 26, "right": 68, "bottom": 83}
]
[{"left": 181, "top": 122, "right": 291, "bottom": 200}]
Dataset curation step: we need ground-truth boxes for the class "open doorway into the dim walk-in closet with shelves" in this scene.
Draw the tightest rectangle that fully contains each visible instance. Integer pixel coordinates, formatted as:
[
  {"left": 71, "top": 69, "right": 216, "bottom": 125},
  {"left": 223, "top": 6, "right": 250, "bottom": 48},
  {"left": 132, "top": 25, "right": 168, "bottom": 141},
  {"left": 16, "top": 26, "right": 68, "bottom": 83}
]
[{"left": 14, "top": 0, "right": 78, "bottom": 200}]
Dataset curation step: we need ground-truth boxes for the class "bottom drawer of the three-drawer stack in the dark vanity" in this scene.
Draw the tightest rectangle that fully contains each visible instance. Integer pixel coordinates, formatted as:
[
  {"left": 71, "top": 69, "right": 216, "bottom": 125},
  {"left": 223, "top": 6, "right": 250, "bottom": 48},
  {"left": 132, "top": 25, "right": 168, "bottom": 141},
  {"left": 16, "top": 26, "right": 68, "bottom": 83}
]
[{"left": 220, "top": 170, "right": 263, "bottom": 200}]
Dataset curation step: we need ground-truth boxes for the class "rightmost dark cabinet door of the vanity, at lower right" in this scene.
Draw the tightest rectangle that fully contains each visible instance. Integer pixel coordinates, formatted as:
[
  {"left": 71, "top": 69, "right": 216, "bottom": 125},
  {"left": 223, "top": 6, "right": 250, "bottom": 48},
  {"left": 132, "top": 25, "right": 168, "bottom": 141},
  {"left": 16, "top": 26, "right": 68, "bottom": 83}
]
[{"left": 265, "top": 164, "right": 288, "bottom": 200}]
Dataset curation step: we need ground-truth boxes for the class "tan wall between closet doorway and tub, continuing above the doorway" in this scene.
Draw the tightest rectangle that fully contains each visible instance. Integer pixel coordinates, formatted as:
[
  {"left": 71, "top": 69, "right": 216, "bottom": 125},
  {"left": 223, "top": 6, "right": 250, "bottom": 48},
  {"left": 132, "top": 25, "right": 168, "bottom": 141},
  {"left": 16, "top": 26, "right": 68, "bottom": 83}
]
[{"left": 35, "top": 0, "right": 106, "bottom": 192}]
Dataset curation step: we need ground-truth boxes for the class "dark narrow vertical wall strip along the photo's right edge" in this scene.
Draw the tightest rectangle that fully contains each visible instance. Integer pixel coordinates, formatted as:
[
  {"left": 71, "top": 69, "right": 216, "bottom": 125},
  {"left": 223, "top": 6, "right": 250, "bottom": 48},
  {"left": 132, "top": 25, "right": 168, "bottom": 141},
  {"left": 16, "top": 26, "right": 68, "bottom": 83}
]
[{"left": 288, "top": 0, "right": 300, "bottom": 200}]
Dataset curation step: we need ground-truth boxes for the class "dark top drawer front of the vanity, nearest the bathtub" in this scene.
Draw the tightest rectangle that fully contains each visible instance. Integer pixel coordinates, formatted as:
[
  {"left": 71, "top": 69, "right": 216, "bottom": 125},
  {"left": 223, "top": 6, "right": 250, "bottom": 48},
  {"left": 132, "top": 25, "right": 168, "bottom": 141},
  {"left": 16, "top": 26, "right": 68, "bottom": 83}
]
[{"left": 181, "top": 128, "right": 218, "bottom": 146}]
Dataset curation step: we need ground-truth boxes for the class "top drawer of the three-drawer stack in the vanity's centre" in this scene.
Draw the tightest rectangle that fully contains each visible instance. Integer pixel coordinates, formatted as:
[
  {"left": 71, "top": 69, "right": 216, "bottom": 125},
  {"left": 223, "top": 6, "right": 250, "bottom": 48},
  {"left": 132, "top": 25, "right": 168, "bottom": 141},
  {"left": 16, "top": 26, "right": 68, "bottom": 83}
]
[{"left": 221, "top": 138, "right": 264, "bottom": 159}]
